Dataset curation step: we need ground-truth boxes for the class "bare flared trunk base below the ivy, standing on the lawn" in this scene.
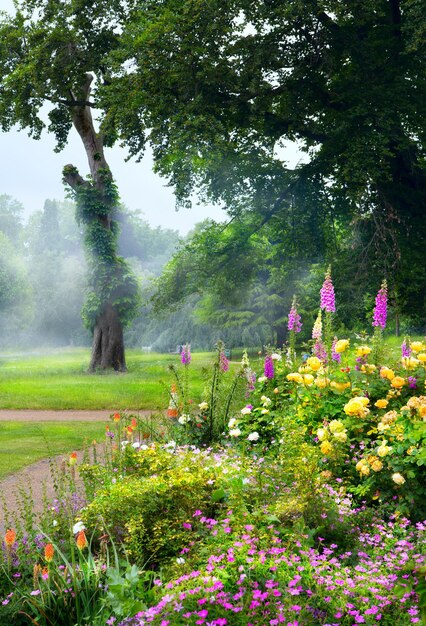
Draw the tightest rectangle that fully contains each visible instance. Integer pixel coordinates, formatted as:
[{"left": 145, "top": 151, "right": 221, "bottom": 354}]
[{"left": 89, "top": 304, "right": 127, "bottom": 372}]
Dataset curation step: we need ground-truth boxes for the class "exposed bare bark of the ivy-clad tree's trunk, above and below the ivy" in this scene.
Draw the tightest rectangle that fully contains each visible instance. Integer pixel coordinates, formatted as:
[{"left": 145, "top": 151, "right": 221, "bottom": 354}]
[{"left": 64, "top": 74, "right": 127, "bottom": 372}]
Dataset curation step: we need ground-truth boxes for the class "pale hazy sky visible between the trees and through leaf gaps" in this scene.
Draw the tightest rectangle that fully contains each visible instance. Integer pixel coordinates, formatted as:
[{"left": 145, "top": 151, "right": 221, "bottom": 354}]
[{"left": 0, "top": 0, "right": 300, "bottom": 235}]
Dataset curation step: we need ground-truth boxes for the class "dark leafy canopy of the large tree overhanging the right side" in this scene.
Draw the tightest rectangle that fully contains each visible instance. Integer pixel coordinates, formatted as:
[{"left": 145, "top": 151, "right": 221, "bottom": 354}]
[{"left": 103, "top": 0, "right": 426, "bottom": 314}]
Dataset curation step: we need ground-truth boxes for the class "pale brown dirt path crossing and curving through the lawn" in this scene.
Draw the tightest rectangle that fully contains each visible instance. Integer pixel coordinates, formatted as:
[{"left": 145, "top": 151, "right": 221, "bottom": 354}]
[{"left": 0, "top": 409, "right": 158, "bottom": 534}]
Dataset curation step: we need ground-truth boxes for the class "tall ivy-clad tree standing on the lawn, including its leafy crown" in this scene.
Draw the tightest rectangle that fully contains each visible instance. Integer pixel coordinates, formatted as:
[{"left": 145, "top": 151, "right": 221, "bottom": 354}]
[{"left": 0, "top": 0, "right": 138, "bottom": 371}]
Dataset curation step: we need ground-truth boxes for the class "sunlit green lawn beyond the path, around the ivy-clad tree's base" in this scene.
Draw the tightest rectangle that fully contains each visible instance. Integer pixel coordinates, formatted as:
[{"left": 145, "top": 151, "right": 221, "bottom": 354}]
[{"left": 0, "top": 348, "right": 220, "bottom": 411}]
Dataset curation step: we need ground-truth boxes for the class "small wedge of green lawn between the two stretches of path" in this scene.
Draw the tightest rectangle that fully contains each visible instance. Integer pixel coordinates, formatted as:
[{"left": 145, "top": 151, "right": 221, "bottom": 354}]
[{"left": 0, "top": 422, "right": 105, "bottom": 479}]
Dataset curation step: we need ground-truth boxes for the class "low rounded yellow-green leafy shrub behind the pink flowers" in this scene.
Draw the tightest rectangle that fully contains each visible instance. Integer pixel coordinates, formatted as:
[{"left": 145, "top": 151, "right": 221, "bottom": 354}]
[{"left": 83, "top": 444, "right": 220, "bottom": 567}]
